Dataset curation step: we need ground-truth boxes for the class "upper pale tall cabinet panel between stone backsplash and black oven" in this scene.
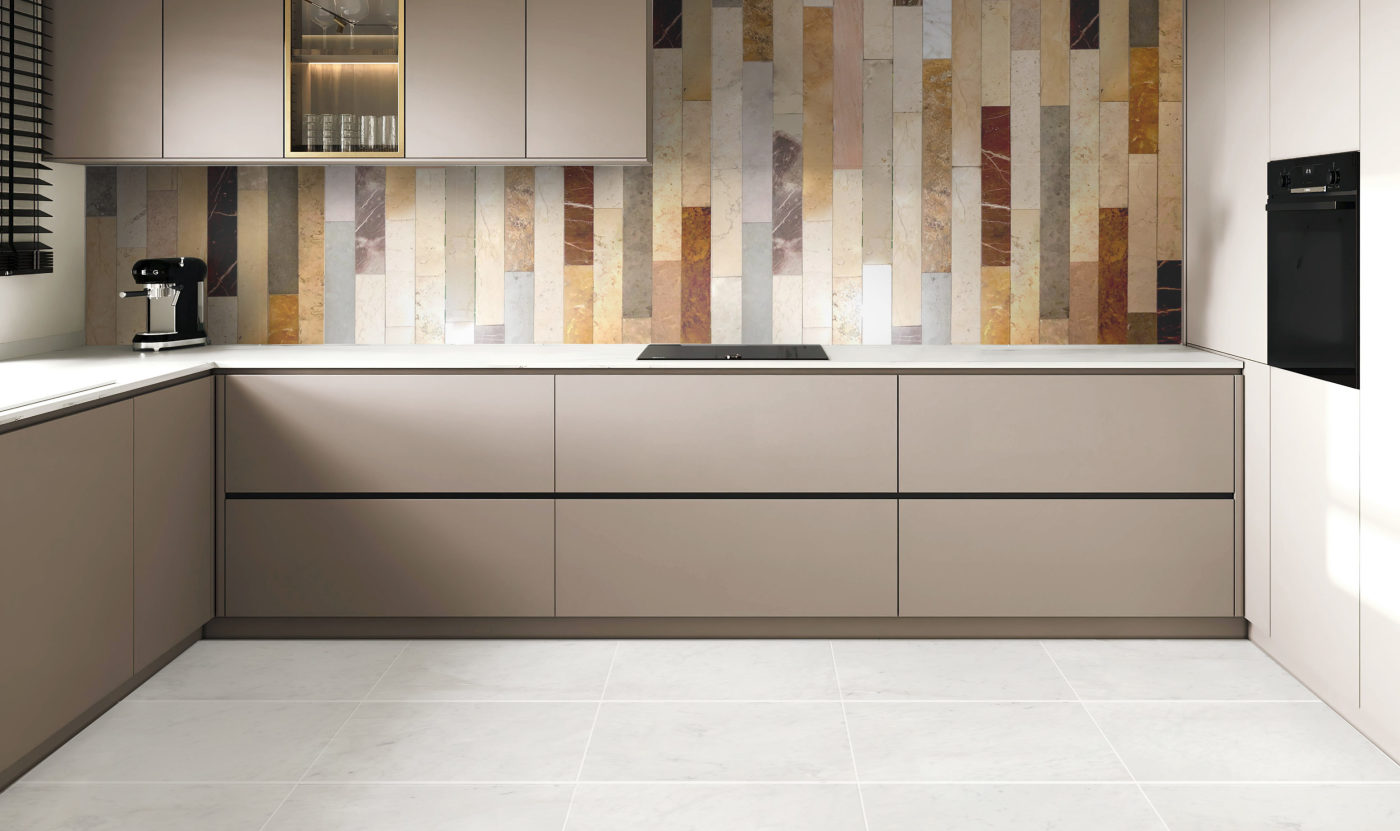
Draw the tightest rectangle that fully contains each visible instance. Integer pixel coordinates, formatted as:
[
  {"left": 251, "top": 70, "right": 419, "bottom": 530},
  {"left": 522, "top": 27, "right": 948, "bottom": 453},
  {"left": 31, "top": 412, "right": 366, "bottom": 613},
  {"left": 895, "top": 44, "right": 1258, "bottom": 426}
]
[{"left": 1186, "top": 0, "right": 1270, "bottom": 362}]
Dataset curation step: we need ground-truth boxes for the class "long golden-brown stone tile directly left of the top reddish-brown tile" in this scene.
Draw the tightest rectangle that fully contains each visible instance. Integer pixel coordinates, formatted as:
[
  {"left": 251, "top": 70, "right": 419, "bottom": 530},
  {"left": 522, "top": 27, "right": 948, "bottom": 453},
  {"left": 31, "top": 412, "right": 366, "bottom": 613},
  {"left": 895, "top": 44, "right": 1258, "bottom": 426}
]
[{"left": 802, "top": 6, "right": 833, "bottom": 224}]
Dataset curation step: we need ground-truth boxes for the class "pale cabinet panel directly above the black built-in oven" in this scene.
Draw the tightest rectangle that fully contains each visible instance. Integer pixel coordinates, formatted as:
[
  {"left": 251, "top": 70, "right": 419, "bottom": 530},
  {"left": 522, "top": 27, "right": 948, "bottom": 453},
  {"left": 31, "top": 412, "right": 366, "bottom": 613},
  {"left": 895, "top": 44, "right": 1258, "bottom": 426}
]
[{"left": 1268, "top": 0, "right": 1355, "bottom": 158}]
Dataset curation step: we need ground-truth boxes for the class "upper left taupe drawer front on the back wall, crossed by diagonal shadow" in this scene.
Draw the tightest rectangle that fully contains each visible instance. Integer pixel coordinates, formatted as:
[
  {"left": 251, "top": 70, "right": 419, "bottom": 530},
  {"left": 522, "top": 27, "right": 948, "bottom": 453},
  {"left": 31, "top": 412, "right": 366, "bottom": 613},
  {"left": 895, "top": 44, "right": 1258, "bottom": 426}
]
[{"left": 225, "top": 374, "right": 554, "bottom": 494}]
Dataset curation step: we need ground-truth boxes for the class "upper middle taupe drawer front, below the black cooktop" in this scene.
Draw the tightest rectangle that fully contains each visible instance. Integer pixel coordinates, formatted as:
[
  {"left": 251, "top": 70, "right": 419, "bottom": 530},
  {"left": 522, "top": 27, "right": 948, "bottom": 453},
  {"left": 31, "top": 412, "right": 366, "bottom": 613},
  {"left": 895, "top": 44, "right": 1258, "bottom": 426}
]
[{"left": 556, "top": 372, "right": 897, "bottom": 494}]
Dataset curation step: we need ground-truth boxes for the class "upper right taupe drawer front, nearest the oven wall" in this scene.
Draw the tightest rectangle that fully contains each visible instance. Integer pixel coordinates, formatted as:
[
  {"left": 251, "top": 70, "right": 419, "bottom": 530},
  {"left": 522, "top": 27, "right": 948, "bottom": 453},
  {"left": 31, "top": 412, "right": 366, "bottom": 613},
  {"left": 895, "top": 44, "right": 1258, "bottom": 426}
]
[{"left": 899, "top": 375, "right": 1235, "bottom": 494}]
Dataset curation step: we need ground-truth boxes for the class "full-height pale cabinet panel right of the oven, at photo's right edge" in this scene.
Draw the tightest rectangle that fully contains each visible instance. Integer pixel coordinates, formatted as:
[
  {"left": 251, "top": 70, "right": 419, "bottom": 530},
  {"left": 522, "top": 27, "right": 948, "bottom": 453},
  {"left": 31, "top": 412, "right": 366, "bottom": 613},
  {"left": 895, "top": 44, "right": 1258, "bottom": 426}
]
[{"left": 1361, "top": 0, "right": 1400, "bottom": 755}]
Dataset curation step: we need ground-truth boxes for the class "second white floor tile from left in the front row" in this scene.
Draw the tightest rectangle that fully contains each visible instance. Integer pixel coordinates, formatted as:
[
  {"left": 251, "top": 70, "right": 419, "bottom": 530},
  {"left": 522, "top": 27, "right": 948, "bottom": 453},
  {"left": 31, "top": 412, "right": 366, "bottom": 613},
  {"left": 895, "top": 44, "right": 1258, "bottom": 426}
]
[{"left": 266, "top": 785, "right": 573, "bottom": 831}]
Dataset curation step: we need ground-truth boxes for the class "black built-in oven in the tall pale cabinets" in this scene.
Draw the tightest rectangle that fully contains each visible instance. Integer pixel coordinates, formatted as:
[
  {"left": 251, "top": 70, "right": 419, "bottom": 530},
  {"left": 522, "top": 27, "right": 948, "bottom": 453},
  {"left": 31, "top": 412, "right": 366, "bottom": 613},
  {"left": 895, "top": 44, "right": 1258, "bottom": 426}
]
[{"left": 1268, "top": 152, "right": 1361, "bottom": 389}]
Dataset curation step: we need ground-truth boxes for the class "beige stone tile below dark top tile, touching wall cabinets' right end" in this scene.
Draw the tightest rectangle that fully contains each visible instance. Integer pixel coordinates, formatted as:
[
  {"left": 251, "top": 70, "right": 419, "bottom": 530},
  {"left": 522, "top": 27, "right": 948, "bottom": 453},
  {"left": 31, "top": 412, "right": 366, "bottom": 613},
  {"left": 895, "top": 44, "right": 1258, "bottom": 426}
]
[{"left": 655, "top": 49, "right": 682, "bottom": 258}]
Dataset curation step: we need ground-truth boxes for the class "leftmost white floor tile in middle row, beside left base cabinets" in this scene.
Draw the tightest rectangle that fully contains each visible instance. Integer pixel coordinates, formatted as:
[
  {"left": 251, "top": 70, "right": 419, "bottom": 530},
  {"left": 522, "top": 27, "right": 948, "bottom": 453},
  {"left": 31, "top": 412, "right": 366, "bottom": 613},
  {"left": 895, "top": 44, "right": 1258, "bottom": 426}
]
[{"left": 24, "top": 701, "right": 356, "bottom": 782}]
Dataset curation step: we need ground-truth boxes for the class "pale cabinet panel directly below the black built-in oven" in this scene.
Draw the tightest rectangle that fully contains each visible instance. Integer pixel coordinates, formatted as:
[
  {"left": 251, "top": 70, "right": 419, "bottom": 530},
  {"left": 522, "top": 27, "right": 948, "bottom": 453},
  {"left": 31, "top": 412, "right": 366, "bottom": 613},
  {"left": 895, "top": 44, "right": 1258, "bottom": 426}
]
[{"left": 1270, "top": 369, "right": 1361, "bottom": 705}]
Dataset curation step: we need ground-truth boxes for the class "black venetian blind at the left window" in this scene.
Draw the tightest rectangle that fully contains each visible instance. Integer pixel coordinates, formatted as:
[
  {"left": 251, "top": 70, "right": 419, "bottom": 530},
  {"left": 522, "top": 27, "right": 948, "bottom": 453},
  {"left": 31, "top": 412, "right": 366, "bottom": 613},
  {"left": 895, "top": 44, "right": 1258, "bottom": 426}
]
[{"left": 0, "top": 0, "right": 53, "bottom": 274}]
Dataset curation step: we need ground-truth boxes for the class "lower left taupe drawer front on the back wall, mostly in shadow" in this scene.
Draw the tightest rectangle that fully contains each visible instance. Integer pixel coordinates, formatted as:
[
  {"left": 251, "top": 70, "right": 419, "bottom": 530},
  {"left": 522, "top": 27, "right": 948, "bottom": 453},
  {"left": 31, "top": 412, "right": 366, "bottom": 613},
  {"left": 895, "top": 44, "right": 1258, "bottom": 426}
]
[{"left": 227, "top": 499, "right": 554, "bottom": 617}]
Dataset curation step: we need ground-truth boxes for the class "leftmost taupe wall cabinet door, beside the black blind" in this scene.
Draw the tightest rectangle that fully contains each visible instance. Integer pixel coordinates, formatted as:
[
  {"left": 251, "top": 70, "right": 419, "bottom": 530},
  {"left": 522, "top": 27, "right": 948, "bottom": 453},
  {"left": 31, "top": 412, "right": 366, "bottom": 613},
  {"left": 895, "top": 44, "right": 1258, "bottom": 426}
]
[{"left": 49, "top": 0, "right": 161, "bottom": 159}]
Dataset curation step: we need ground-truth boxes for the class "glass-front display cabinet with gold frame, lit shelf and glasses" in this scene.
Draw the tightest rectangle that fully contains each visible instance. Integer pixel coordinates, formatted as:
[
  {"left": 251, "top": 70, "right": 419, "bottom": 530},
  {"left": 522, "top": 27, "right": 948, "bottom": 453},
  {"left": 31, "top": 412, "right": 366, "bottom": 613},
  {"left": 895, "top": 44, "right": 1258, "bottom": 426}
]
[{"left": 286, "top": 0, "right": 403, "bottom": 158}]
